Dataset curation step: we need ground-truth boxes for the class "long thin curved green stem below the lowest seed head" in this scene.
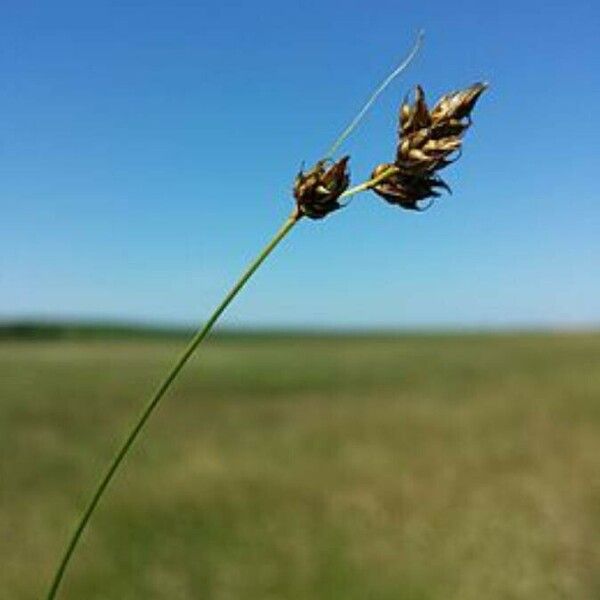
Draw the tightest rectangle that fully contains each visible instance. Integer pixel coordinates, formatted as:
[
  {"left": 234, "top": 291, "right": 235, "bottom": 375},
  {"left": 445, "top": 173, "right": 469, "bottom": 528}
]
[{"left": 46, "top": 213, "right": 300, "bottom": 600}]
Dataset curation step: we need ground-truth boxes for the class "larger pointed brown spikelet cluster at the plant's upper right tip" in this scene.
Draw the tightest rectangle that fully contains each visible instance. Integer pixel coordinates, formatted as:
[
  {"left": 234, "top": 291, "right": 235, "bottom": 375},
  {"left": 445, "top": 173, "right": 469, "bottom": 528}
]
[{"left": 372, "top": 83, "right": 487, "bottom": 210}]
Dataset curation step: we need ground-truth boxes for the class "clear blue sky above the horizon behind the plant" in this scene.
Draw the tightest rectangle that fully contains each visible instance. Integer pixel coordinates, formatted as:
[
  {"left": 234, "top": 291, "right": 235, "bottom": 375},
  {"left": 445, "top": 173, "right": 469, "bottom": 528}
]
[{"left": 0, "top": 0, "right": 600, "bottom": 327}]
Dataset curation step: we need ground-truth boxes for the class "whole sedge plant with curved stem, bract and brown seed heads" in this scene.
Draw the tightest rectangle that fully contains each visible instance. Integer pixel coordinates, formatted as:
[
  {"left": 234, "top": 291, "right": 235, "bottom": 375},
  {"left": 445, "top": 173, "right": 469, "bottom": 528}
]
[{"left": 45, "top": 32, "right": 487, "bottom": 600}]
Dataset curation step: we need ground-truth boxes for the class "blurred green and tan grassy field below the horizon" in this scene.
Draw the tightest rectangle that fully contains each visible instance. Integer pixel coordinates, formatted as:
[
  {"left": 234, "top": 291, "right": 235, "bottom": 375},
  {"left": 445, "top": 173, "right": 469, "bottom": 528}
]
[{"left": 0, "top": 334, "right": 600, "bottom": 600}]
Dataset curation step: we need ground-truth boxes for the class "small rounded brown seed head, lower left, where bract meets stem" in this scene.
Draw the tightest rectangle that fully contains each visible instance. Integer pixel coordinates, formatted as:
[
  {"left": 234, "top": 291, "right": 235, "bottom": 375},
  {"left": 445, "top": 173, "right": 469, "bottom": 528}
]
[{"left": 294, "top": 156, "right": 350, "bottom": 219}]
